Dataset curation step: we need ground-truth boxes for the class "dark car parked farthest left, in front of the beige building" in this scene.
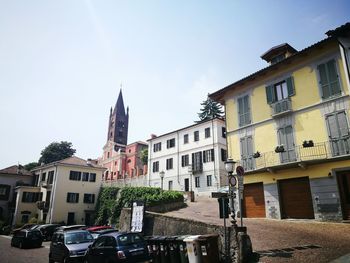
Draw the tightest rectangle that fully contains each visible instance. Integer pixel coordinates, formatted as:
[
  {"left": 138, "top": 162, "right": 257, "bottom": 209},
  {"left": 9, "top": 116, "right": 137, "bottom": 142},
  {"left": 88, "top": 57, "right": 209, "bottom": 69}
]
[{"left": 11, "top": 229, "right": 43, "bottom": 248}]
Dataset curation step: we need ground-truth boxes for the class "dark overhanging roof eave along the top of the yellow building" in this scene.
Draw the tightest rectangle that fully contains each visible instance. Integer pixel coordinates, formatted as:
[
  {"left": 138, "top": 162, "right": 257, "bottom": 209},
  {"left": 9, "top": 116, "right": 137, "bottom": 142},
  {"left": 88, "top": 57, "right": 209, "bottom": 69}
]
[{"left": 209, "top": 23, "right": 350, "bottom": 103}]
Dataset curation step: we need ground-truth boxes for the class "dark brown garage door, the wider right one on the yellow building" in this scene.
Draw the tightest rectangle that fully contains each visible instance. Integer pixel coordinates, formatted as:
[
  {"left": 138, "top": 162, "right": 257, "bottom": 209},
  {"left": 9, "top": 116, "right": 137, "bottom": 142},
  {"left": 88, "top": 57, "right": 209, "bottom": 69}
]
[{"left": 278, "top": 177, "right": 314, "bottom": 219}]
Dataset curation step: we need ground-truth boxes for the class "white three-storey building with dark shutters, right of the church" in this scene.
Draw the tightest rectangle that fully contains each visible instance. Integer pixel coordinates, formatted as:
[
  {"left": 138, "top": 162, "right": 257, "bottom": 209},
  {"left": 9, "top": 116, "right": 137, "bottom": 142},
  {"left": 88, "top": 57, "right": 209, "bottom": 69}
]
[{"left": 148, "top": 118, "right": 227, "bottom": 196}]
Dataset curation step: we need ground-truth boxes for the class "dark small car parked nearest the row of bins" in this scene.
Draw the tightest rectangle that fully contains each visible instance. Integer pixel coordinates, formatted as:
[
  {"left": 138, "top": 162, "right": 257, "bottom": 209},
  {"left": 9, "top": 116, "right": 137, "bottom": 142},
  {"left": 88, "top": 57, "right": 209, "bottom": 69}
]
[{"left": 84, "top": 232, "right": 151, "bottom": 263}]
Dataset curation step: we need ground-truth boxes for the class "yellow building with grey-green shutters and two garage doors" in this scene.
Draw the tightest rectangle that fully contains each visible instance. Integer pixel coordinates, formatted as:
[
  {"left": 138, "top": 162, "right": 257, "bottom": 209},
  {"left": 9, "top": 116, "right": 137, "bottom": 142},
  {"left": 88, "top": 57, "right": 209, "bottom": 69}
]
[{"left": 210, "top": 23, "right": 350, "bottom": 220}]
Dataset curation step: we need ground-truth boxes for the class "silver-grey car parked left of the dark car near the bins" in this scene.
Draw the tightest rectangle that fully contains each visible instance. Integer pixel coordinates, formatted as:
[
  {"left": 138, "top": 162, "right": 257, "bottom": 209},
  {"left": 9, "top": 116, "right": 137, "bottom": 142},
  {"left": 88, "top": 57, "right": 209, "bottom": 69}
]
[{"left": 49, "top": 229, "right": 94, "bottom": 263}]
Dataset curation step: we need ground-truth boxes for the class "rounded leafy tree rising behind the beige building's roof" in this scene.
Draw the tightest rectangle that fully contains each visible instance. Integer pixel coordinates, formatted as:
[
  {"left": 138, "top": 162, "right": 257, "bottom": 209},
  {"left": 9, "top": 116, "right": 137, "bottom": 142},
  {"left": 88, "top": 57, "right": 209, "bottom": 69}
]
[{"left": 39, "top": 141, "right": 76, "bottom": 163}]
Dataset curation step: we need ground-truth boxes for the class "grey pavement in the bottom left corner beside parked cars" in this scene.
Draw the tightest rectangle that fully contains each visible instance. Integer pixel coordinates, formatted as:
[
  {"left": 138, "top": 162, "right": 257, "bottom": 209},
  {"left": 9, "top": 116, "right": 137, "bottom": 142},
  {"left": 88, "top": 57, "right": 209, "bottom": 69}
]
[{"left": 0, "top": 236, "right": 50, "bottom": 263}]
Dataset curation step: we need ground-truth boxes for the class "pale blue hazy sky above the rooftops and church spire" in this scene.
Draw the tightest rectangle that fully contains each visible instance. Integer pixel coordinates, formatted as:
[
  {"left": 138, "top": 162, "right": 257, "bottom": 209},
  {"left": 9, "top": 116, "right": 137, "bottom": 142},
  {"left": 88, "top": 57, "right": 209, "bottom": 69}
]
[{"left": 0, "top": 0, "right": 350, "bottom": 169}]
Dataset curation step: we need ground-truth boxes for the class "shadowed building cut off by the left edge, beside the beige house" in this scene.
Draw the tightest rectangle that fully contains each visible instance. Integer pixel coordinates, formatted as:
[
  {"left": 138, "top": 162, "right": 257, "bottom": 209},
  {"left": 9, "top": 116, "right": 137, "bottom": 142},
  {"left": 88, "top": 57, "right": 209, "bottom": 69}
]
[{"left": 0, "top": 165, "right": 33, "bottom": 223}]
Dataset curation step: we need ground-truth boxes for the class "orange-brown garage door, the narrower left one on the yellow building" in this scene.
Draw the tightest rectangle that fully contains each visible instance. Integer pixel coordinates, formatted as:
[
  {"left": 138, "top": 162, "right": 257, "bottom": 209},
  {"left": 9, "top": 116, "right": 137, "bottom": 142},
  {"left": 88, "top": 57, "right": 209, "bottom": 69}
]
[{"left": 243, "top": 183, "right": 266, "bottom": 217}]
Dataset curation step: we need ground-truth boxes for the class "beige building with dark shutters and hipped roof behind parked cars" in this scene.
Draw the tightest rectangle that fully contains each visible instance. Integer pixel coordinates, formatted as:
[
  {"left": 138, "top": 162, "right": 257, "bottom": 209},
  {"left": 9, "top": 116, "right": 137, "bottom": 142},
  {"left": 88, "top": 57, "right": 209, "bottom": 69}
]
[{"left": 13, "top": 156, "right": 105, "bottom": 225}]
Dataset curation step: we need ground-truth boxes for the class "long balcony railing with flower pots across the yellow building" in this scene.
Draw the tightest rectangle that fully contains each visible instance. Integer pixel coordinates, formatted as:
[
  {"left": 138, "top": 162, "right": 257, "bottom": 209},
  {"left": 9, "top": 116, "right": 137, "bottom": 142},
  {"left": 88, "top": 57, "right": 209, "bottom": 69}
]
[{"left": 238, "top": 137, "right": 350, "bottom": 174}]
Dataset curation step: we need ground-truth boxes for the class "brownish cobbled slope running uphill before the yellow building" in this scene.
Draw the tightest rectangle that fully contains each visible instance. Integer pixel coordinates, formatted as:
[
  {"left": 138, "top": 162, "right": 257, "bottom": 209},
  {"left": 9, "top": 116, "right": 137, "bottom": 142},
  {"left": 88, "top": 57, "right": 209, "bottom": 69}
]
[{"left": 166, "top": 198, "right": 350, "bottom": 263}]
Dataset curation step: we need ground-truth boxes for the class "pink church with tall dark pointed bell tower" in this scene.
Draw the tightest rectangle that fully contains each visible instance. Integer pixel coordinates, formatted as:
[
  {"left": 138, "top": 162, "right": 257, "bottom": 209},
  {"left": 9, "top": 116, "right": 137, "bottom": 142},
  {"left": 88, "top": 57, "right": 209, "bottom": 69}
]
[{"left": 98, "top": 91, "right": 147, "bottom": 186}]
